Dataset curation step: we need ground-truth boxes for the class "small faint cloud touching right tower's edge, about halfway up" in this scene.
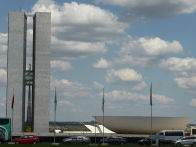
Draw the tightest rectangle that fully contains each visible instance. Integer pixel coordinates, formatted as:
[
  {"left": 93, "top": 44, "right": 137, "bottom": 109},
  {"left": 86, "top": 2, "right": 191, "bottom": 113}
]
[{"left": 50, "top": 60, "right": 72, "bottom": 72}]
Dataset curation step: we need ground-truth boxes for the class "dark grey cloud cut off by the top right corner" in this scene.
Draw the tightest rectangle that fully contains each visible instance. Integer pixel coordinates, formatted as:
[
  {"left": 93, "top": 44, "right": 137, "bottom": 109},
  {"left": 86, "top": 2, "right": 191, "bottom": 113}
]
[{"left": 95, "top": 0, "right": 196, "bottom": 21}]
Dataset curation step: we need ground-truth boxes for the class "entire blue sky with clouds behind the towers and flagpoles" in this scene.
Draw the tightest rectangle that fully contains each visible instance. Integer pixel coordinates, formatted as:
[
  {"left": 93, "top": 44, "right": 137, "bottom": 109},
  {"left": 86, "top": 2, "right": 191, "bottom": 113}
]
[{"left": 0, "top": 0, "right": 196, "bottom": 121}]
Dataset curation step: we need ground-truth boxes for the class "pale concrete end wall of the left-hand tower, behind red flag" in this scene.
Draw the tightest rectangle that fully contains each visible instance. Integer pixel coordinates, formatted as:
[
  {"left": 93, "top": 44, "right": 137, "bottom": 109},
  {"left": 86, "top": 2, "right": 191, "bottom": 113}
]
[{"left": 6, "top": 12, "right": 26, "bottom": 132}]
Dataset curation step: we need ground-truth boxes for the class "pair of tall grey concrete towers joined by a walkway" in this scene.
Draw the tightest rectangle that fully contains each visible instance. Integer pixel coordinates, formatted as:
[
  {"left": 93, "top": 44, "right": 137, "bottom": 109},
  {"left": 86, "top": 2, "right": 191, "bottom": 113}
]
[{"left": 6, "top": 11, "right": 51, "bottom": 134}]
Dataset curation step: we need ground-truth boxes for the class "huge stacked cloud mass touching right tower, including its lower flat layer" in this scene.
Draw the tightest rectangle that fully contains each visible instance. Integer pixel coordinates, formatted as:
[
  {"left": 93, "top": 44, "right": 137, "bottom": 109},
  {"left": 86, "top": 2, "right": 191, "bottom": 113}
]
[{"left": 32, "top": 0, "right": 129, "bottom": 59}]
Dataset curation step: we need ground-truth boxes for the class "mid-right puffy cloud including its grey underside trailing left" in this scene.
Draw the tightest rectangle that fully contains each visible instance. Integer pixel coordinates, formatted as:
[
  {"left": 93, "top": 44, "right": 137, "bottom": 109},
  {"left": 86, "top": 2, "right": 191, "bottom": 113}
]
[{"left": 107, "top": 37, "right": 183, "bottom": 67}]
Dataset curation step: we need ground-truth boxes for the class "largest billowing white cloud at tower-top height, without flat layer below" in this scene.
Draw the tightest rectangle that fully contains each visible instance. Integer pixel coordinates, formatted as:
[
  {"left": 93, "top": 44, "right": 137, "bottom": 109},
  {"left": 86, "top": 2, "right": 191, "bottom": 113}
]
[{"left": 32, "top": 0, "right": 128, "bottom": 41}]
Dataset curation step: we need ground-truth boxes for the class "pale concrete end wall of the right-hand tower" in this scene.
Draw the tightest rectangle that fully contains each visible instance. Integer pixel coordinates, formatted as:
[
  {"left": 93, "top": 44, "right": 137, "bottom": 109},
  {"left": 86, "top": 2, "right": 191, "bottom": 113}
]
[{"left": 33, "top": 12, "right": 51, "bottom": 133}]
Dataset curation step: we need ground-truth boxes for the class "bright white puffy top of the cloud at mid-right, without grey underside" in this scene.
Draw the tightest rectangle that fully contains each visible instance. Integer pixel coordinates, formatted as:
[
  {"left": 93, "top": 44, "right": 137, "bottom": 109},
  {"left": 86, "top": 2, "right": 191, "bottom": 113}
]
[{"left": 119, "top": 37, "right": 183, "bottom": 57}]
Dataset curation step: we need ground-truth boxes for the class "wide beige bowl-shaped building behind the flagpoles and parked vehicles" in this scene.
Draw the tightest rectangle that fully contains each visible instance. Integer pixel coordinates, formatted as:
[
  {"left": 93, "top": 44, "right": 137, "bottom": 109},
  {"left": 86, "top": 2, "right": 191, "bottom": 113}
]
[{"left": 94, "top": 116, "right": 194, "bottom": 134}]
